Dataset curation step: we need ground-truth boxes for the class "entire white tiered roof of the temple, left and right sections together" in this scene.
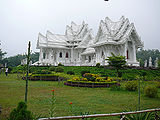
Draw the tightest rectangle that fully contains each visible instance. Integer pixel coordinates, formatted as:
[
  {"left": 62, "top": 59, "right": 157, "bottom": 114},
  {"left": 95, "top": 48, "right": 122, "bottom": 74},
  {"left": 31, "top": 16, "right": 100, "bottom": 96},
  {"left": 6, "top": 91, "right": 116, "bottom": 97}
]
[{"left": 37, "top": 16, "right": 143, "bottom": 49}]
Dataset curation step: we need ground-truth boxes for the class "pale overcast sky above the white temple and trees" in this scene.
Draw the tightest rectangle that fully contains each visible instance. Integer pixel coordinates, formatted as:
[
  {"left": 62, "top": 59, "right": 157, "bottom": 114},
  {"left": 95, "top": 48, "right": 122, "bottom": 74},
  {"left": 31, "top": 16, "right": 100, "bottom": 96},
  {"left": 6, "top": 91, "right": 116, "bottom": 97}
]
[{"left": 0, "top": 0, "right": 160, "bottom": 57}]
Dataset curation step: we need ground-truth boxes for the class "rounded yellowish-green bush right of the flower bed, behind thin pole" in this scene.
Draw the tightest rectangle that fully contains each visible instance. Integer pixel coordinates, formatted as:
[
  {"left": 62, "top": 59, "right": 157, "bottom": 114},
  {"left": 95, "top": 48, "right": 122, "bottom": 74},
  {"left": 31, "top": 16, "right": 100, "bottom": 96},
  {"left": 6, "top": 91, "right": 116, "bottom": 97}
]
[{"left": 125, "top": 81, "right": 138, "bottom": 91}]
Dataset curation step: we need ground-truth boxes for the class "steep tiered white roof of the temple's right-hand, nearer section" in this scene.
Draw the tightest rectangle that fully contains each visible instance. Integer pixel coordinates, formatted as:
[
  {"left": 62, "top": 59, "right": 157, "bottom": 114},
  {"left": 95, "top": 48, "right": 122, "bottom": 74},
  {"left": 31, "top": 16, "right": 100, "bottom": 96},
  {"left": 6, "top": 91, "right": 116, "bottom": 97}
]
[{"left": 93, "top": 16, "right": 143, "bottom": 47}]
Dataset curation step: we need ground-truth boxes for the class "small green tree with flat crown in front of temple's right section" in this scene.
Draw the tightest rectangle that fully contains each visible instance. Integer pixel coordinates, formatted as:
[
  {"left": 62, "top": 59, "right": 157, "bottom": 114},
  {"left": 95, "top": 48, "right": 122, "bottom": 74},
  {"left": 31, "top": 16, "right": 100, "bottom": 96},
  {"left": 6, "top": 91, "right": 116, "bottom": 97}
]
[{"left": 107, "top": 53, "right": 126, "bottom": 77}]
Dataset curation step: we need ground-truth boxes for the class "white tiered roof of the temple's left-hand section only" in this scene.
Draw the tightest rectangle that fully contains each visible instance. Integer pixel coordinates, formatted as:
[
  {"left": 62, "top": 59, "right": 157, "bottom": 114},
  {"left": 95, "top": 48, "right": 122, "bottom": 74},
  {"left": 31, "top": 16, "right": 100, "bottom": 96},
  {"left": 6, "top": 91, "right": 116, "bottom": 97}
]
[{"left": 37, "top": 22, "right": 93, "bottom": 48}]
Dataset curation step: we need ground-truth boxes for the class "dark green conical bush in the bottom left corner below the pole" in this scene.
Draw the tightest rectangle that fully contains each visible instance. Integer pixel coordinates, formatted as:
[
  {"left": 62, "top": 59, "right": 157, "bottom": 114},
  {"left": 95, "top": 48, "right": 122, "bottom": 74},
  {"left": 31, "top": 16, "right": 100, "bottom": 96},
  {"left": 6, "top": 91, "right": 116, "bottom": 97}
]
[{"left": 9, "top": 102, "right": 33, "bottom": 120}]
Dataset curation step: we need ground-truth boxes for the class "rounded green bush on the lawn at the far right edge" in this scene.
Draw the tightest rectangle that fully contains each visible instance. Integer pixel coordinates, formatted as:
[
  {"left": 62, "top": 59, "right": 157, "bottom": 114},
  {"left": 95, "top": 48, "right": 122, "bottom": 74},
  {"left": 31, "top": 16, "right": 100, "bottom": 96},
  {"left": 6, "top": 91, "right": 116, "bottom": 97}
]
[{"left": 144, "top": 86, "right": 158, "bottom": 98}]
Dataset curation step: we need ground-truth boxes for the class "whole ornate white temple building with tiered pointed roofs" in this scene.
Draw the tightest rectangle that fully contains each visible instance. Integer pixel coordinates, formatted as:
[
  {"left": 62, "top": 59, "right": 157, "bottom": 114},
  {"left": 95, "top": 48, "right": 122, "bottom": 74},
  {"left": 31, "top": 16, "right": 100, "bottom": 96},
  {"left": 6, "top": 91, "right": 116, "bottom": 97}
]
[{"left": 35, "top": 16, "right": 143, "bottom": 66}]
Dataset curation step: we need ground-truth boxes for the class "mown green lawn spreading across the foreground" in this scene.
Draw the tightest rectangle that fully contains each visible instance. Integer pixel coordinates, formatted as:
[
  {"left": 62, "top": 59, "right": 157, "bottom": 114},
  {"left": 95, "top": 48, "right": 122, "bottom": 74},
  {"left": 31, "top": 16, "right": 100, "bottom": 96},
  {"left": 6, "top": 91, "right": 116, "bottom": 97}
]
[{"left": 0, "top": 74, "right": 160, "bottom": 120}]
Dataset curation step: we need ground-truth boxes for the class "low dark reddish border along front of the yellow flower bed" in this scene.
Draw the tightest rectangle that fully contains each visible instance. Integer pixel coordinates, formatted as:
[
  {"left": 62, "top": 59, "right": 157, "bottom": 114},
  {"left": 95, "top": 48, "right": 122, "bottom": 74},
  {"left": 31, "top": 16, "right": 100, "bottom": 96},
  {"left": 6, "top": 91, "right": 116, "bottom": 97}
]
[{"left": 64, "top": 81, "right": 118, "bottom": 88}]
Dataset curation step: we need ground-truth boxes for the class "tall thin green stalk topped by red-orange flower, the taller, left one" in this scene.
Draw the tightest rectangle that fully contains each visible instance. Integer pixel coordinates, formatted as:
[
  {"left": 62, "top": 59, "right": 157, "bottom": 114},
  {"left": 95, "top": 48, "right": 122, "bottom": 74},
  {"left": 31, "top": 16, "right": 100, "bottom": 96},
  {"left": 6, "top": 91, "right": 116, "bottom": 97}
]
[{"left": 49, "top": 90, "right": 56, "bottom": 117}]
